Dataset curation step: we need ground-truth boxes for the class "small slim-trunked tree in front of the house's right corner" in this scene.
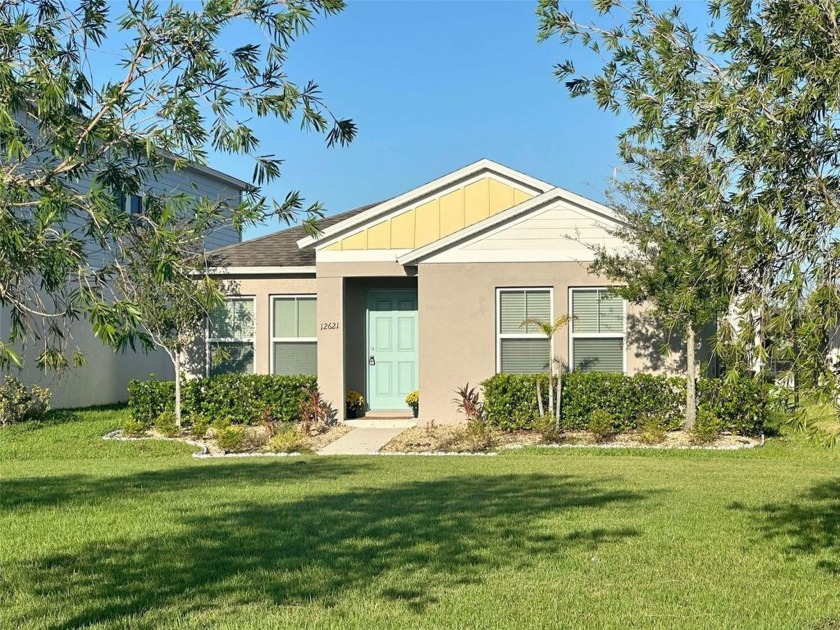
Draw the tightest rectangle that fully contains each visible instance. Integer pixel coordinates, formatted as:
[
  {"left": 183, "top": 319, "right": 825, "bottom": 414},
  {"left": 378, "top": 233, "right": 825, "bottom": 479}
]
[{"left": 591, "top": 147, "right": 731, "bottom": 430}]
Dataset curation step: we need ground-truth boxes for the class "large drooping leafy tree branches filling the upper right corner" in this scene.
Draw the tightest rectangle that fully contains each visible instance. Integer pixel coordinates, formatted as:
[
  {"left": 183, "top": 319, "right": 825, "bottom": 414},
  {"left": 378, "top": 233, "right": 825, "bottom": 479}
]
[{"left": 538, "top": 0, "right": 840, "bottom": 404}]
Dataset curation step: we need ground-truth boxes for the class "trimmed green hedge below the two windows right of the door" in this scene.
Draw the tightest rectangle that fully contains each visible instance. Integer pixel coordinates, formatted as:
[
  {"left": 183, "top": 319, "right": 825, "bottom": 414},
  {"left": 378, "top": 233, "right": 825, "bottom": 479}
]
[{"left": 482, "top": 372, "right": 767, "bottom": 435}]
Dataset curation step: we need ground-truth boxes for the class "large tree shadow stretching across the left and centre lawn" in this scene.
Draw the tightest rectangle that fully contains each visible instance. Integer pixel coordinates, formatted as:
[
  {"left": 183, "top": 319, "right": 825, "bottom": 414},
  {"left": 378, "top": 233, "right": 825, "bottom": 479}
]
[{"left": 6, "top": 464, "right": 647, "bottom": 628}]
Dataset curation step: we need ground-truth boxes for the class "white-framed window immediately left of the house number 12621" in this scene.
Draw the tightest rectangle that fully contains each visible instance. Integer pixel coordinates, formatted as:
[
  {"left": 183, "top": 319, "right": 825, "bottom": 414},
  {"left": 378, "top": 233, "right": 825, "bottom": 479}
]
[{"left": 271, "top": 295, "right": 318, "bottom": 375}]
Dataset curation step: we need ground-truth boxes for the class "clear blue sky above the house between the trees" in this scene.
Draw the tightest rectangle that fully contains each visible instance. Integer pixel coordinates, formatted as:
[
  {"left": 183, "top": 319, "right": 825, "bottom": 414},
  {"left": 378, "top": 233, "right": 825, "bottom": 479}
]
[{"left": 90, "top": 0, "right": 705, "bottom": 238}]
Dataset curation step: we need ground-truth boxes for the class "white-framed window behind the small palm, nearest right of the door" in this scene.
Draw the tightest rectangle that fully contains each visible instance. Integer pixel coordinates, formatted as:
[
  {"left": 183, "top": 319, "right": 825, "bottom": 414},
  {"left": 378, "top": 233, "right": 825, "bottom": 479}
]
[{"left": 496, "top": 289, "right": 553, "bottom": 374}]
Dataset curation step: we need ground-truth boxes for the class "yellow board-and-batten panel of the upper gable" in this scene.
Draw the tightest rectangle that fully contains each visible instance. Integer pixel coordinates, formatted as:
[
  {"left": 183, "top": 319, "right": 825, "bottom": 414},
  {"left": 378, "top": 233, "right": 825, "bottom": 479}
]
[{"left": 325, "top": 177, "right": 533, "bottom": 251}]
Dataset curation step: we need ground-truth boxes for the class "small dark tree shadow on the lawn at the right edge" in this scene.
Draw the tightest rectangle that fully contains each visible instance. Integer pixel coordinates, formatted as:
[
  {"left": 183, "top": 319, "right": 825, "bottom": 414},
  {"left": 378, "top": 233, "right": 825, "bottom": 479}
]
[{"left": 730, "top": 479, "right": 840, "bottom": 575}]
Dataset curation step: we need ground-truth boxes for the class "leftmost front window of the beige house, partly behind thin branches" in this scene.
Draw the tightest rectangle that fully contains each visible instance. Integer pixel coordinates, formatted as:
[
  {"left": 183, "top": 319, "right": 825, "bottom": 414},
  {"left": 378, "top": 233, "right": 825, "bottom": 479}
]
[{"left": 207, "top": 297, "right": 255, "bottom": 376}]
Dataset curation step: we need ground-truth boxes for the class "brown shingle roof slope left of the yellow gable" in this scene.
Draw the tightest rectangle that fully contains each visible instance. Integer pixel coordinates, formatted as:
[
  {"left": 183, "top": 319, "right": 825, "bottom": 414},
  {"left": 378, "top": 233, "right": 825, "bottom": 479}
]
[{"left": 209, "top": 201, "right": 382, "bottom": 267}]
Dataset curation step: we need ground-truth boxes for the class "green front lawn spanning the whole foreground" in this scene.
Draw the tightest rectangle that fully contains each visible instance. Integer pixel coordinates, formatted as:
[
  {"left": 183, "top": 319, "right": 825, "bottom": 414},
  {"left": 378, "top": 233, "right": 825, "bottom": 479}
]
[{"left": 0, "top": 409, "right": 840, "bottom": 629}]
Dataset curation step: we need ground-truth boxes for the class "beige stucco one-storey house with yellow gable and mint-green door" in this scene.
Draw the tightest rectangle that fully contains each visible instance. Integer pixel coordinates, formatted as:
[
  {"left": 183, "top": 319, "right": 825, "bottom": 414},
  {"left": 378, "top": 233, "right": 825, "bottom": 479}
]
[{"left": 203, "top": 160, "right": 679, "bottom": 422}]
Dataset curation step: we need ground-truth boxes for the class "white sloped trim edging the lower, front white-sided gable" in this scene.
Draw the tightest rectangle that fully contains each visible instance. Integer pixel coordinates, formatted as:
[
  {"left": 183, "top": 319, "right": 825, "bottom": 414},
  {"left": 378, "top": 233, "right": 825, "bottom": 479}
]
[{"left": 397, "top": 188, "right": 620, "bottom": 265}]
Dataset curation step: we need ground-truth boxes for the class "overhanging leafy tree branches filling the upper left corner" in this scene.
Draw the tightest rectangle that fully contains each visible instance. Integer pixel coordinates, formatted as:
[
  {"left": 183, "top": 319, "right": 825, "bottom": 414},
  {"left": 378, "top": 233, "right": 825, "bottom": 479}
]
[{"left": 0, "top": 0, "right": 356, "bottom": 368}]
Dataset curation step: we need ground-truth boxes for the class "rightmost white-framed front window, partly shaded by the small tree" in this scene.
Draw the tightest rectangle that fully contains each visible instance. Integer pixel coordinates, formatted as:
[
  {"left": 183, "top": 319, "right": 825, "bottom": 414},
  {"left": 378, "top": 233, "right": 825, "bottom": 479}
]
[{"left": 571, "top": 289, "right": 625, "bottom": 372}]
